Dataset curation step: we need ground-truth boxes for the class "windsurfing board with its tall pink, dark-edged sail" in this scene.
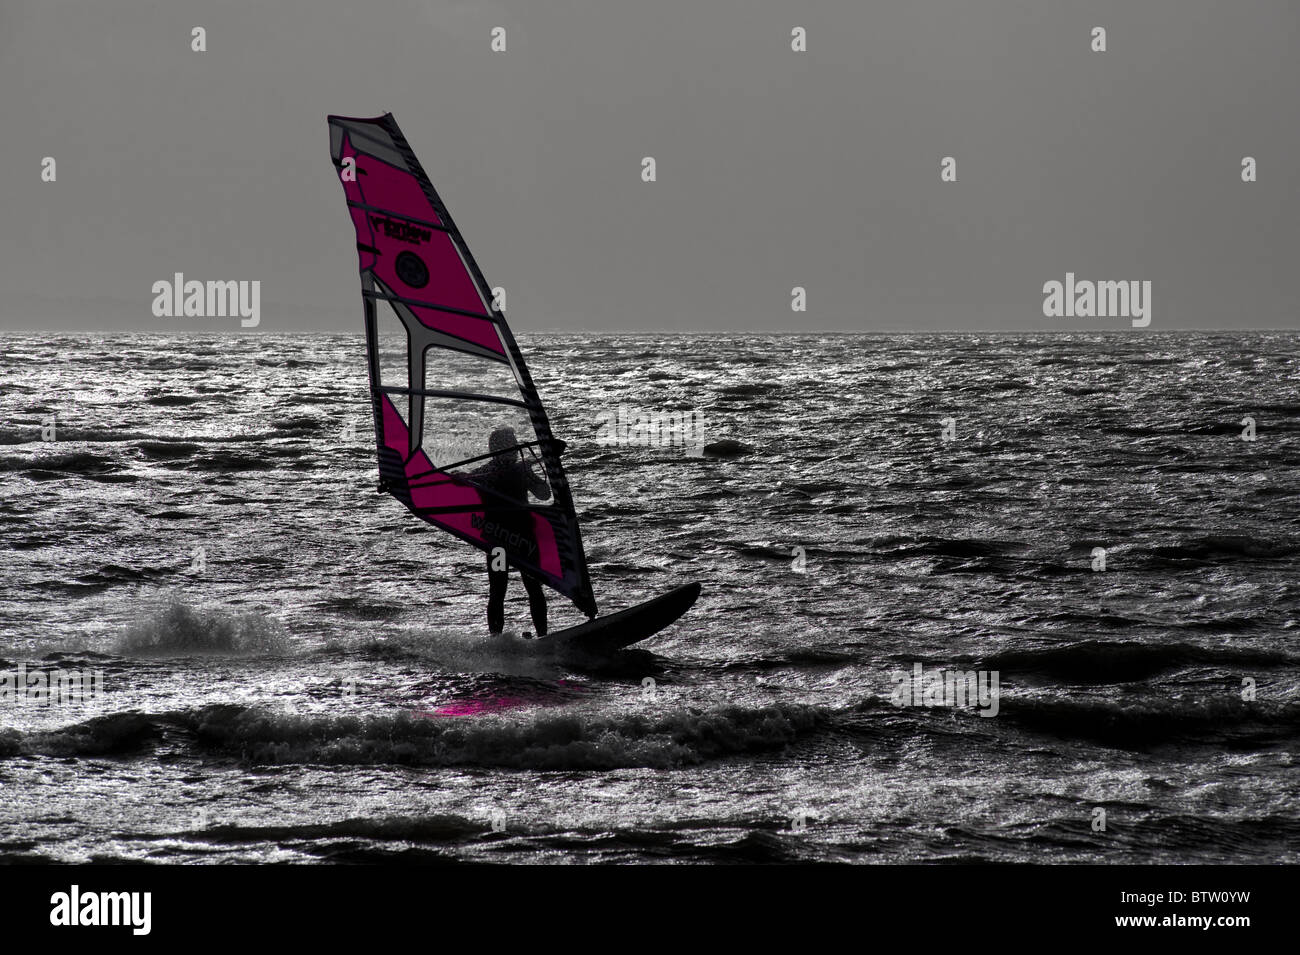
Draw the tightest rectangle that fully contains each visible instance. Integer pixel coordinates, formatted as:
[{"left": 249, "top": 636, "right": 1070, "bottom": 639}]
[{"left": 329, "top": 113, "right": 698, "bottom": 646}]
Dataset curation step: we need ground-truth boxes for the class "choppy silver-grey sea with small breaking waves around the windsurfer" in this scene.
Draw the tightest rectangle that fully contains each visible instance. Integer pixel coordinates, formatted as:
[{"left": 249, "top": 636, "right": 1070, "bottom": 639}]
[{"left": 0, "top": 333, "right": 1300, "bottom": 864}]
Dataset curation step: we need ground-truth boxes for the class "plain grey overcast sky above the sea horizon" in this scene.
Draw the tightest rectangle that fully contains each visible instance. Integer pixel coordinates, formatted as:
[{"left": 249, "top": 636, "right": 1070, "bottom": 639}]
[{"left": 0, "top": 0, "right": 1300, "bottom": 333}]
